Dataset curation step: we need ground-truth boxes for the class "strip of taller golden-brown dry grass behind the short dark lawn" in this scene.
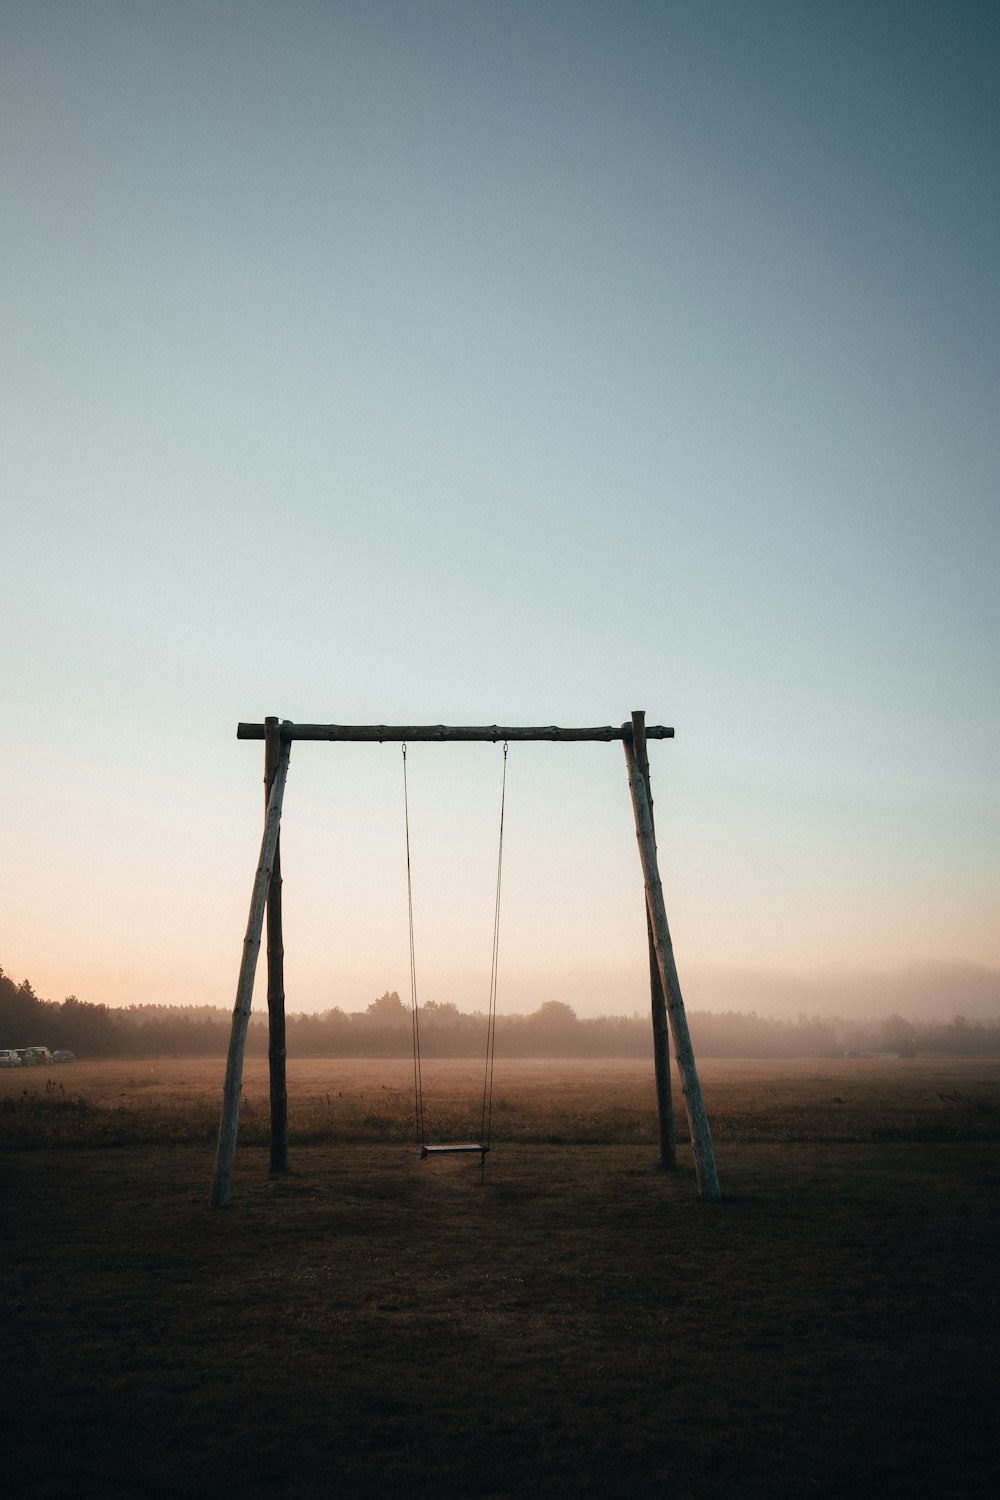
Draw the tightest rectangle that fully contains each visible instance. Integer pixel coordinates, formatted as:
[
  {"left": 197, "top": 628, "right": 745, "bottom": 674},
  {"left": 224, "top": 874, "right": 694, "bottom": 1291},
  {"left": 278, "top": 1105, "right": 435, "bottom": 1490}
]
[{"left": 0, "top": 1058, "right": 1000, "bottom": 1148}]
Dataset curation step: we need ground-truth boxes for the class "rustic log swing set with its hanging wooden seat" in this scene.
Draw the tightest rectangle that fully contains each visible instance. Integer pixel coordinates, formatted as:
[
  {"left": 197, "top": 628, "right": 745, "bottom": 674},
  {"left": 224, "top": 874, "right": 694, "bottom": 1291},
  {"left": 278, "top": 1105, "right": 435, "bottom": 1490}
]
[{"left": 210, "top": 711, "right": 721, "bottom": 1208}]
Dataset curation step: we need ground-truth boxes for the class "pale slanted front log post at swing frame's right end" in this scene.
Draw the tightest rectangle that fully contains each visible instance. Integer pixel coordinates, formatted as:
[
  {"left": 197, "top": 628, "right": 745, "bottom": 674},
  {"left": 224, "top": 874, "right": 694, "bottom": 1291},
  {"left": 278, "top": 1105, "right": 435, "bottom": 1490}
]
[{"left": 622, "top": 735, "right": 723, "bottom": 1199}]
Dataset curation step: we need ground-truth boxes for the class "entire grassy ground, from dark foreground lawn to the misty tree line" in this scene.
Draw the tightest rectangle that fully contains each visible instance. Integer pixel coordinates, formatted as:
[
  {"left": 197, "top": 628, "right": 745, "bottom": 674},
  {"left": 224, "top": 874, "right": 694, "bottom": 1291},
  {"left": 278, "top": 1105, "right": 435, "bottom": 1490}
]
[{"left": 0, "top": 1059, "right": 1000, "bottom": 1500}]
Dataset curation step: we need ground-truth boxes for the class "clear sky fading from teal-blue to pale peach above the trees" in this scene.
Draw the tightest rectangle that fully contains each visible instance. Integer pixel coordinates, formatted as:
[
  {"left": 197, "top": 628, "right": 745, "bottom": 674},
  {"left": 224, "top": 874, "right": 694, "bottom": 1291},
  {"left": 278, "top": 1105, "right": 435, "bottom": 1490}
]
[{"left": 0, "top": 0, "right": 1000, "bottom": 1016}]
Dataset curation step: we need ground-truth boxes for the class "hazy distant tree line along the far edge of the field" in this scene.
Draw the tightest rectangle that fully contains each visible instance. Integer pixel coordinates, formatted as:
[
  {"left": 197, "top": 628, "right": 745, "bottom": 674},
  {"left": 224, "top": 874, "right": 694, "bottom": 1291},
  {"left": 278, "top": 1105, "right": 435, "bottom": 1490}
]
[{"left": 0, "top": 969, "right": 1000, "bottom": 1058}]
